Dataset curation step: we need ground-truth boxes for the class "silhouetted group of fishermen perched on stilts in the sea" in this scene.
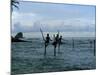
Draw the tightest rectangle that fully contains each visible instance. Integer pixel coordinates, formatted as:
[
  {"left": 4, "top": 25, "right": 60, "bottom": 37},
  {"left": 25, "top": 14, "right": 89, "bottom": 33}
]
[{"left": 44, "top": 33, "right": 62, "bottom": 56}]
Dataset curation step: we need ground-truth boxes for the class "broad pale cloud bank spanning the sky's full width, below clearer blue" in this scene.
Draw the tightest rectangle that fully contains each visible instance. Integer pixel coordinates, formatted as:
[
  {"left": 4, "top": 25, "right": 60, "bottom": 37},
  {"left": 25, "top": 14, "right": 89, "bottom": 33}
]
[{"left": 12, "top": 12, "right": 95, "bottom": 32}]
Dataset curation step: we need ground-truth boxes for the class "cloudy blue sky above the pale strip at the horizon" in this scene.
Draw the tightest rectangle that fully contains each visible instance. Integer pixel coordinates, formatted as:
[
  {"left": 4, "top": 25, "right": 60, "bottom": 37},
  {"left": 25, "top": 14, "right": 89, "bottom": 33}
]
[{"left": 12, "top": 1, "right": 96, "bottom": 32}]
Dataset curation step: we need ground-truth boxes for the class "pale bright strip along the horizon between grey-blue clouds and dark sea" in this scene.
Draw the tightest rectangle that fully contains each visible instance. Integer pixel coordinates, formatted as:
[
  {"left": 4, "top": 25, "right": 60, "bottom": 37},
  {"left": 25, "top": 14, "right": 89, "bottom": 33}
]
[{"left": 12, "top": 32, "right": 95, "bottom": 38}]
